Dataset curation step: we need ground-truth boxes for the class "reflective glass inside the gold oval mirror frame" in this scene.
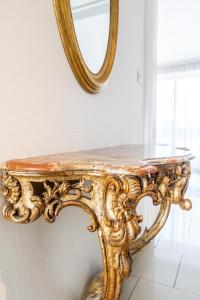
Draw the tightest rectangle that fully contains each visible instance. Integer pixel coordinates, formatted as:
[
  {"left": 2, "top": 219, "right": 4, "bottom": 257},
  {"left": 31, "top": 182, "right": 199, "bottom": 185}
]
[{"left": 70, "top": 0, "right": 110, "bottom": 74}]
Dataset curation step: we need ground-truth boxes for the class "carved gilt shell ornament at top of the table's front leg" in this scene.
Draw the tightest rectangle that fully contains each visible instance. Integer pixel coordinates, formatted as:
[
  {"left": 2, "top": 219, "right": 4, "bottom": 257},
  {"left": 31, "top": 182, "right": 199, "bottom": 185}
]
[{"left": 106, "top": 177, "right": 142, "bottom": 244}]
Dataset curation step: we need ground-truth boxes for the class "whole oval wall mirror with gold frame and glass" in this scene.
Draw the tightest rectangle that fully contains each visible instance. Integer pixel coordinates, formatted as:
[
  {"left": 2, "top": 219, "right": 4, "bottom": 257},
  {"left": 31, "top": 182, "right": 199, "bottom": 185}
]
[{"left": 54, "top": 0, "right": 119, "bottom": 93}]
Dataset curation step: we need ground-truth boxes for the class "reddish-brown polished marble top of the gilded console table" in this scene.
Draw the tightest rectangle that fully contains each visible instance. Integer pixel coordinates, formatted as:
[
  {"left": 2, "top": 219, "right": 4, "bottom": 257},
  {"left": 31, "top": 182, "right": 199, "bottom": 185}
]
[{"left": 1, "top": 145, "right": 193, "bottom": 175}]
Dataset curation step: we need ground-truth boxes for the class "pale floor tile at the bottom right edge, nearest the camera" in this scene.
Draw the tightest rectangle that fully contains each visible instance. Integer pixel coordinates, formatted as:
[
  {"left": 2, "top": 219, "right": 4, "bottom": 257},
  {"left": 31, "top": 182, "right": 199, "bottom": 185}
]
[{"left": 130, "top": 279, "right": 199, "bottom": 300}]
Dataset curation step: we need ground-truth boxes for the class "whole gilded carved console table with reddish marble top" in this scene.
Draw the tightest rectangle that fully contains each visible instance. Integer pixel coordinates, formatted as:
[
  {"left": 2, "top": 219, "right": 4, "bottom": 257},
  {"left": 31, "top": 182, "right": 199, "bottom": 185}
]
[{"left": 1, "top": 145, "right": 192, "bottom": 300}]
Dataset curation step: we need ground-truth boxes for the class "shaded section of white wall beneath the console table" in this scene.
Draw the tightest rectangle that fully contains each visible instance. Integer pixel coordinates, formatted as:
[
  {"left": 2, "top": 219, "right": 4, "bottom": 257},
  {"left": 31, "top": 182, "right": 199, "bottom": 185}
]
[{"left": 0, "top": 196, "right": 102, "bottom": 300}]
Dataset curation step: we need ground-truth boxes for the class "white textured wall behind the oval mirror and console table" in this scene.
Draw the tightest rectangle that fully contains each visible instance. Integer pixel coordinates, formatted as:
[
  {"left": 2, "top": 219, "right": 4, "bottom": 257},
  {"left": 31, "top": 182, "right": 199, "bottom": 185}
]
[{"left": 0, "top": 0, "right": 145, "bottom": 300}]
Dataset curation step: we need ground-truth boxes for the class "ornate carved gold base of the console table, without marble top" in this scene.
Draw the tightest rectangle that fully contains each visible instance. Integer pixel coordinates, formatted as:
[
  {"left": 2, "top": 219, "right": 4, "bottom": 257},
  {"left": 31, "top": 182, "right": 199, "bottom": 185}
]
[{"left": 1, "top": 162, "right": 192, "bottom": 300}]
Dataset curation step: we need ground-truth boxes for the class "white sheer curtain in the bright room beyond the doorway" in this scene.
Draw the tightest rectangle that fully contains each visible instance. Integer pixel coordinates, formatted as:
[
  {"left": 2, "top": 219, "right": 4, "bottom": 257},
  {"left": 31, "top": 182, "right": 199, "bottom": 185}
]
[{"left": 156, "top": 70, "right": 200, "bottom": 171}]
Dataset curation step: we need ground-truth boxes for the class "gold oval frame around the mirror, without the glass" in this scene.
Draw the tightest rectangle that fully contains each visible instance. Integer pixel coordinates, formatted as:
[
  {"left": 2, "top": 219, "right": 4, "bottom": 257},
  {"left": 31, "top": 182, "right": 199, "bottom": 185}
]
[{"left": 54, "top": 0, "right": 119, "bottom": 94}]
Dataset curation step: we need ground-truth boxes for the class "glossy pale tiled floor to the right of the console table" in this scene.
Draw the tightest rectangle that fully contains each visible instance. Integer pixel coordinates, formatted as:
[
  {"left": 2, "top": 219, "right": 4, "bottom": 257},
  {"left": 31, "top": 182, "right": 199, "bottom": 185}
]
[{"left": 120, "top": 175, "right": 200, "bottom": 300}]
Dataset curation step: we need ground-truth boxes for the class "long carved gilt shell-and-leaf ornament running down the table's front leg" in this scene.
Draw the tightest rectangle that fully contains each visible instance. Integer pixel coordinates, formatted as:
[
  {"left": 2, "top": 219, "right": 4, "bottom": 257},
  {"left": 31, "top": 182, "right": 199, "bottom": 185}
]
[{"left": 105, "top": 177, "right": 143, "bottom": 278}]
